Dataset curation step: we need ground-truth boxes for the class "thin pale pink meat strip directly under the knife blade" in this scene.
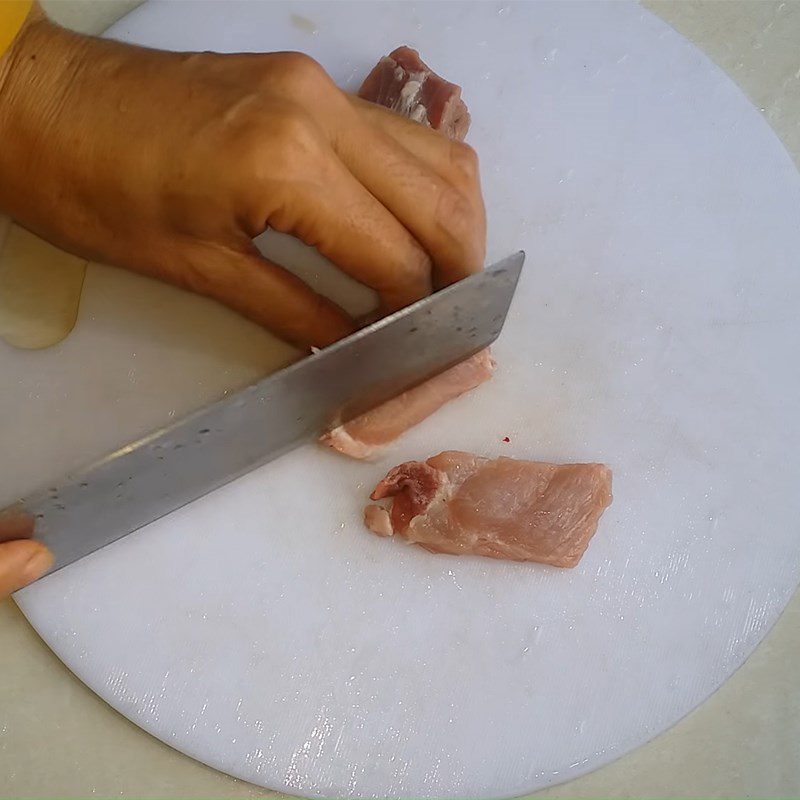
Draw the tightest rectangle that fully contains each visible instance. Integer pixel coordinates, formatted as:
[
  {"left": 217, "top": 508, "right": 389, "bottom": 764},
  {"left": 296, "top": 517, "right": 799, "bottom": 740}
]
[{"left": 320, "top": 350, "right": 494, "bottom": 458}]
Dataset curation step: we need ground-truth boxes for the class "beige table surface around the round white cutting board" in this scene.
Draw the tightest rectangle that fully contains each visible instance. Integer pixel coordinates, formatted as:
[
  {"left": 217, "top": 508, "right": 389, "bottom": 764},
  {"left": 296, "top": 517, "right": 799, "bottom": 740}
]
[{"left": 0, "top": 0, "right": 800, "bottom": 798}]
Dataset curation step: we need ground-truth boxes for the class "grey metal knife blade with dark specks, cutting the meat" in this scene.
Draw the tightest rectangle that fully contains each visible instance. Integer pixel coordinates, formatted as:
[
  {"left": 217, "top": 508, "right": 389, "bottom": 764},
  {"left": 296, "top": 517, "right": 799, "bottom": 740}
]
[{"left": 0, "top": 252, "right": 525, "bottom": 572}]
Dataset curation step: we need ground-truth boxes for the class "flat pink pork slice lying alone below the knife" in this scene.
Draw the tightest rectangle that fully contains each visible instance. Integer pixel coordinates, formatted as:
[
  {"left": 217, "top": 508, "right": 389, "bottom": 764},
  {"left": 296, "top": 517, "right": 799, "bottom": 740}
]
[{"left": 364, "top": 451, "right": 611, "bottom": 567}]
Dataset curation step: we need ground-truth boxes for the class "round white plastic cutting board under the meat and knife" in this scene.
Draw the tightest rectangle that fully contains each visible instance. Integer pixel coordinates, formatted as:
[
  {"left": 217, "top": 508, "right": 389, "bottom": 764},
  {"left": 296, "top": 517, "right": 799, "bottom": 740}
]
[{"left": 6, "top": 2, "right": 800, "bottom": 797}]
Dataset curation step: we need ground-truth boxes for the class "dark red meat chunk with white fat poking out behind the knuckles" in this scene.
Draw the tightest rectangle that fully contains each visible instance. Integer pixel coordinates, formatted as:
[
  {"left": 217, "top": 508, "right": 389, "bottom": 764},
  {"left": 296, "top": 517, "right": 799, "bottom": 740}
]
[{"left": 358, "top": 47, "right": 470, "bottom": 141}]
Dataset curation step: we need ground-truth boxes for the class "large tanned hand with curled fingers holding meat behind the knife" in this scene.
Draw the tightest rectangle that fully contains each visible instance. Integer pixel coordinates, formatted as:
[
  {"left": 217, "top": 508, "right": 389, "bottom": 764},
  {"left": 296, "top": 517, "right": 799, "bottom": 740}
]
[{"left": 0, "top": 19, "right": 486, "bottom": 346}]
